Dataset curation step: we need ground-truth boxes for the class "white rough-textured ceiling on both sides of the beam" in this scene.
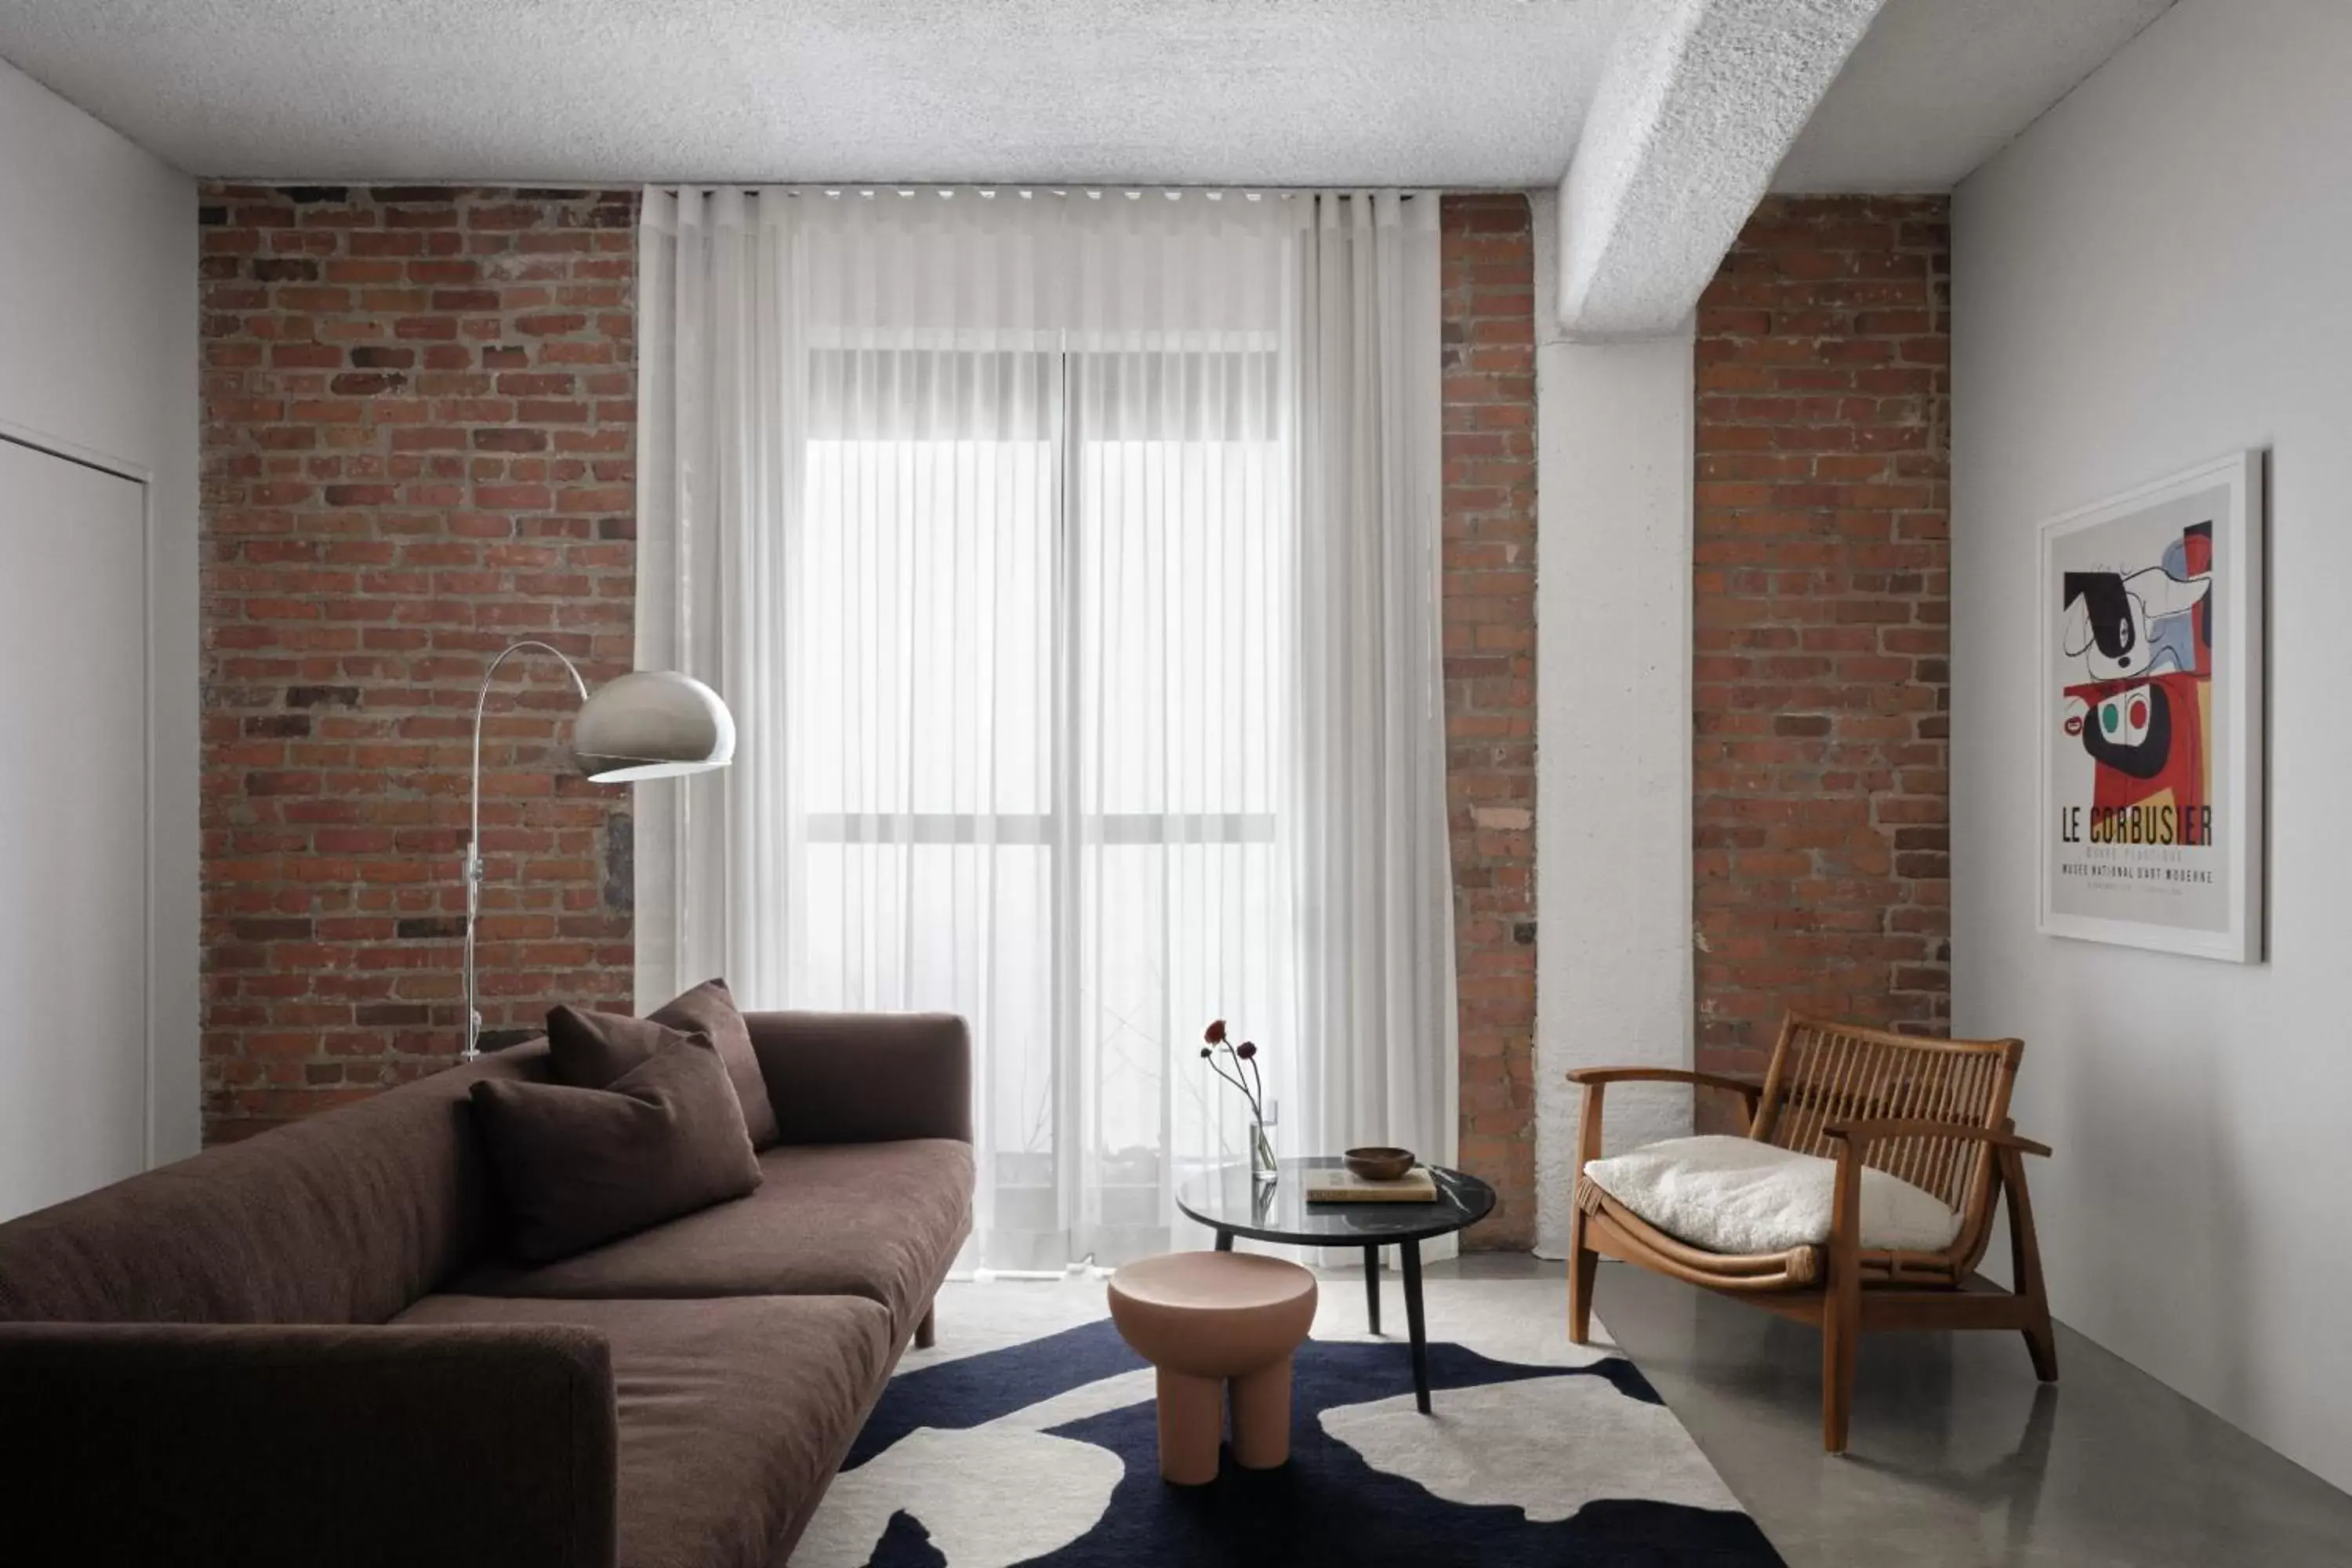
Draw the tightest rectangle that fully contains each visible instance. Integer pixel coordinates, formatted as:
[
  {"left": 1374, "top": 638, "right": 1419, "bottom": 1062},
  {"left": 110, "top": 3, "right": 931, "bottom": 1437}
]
[{"left": 0, "top": 0, "right": 2171, "bottom": 191}]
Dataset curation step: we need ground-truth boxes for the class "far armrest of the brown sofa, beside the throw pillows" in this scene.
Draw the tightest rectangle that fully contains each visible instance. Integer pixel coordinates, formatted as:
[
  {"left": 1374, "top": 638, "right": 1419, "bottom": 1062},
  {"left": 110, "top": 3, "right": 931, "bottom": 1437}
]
[{"left": 743, "top": 1013, "right": 971, "bottom": 1142}]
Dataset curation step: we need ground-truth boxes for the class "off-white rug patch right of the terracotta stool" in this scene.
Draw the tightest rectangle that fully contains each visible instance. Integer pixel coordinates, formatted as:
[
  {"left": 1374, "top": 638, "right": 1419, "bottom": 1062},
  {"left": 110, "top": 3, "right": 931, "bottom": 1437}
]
[{"left": 1322, "top": 1377, "right": 1740, "bottom": 1523}]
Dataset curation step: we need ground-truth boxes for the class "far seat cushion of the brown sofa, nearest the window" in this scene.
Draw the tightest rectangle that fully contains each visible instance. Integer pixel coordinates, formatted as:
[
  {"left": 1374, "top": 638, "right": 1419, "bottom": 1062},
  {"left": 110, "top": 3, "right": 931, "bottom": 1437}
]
[{"left": 449, "top": 1138, "right": 971, "bottom": 1340}]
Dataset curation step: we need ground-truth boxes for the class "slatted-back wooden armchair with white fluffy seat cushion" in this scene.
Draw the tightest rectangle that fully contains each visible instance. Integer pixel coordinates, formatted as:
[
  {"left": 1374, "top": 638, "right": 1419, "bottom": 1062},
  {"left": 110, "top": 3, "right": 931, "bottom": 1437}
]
[{"left": 1569, "top": 1013, "right": 2058, "bottom": 1453}]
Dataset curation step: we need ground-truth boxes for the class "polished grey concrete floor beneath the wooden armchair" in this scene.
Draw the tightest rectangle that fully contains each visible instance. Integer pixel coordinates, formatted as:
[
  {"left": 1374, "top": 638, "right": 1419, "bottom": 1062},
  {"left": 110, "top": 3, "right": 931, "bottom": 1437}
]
[{"left": 1430, "top": 1253, "right": 2352, "bottom": 1568}]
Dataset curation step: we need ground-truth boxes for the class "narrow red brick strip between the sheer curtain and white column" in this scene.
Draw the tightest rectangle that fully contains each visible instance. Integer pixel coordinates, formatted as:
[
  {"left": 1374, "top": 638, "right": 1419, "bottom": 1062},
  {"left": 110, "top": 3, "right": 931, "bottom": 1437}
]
[{"left": 1442, "top": 195, "right": 1536, "bottom": 1248}]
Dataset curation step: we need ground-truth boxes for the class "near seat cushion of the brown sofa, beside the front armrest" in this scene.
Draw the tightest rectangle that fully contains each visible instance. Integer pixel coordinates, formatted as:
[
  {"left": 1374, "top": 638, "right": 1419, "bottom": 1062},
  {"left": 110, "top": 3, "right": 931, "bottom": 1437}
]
[{"left": 400, "top": 1288, "right": 891, "bottom": 1568}]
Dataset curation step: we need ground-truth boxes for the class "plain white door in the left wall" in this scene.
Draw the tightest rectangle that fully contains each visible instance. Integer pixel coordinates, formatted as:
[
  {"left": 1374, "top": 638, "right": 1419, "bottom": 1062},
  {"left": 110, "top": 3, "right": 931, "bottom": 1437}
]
[{"left": 0, "top": 440, "right": 148, "bottom": 1220}]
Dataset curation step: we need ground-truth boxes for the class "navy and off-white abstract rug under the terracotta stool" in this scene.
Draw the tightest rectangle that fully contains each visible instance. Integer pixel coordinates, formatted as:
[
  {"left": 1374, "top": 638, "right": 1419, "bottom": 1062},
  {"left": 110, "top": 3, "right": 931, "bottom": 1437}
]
[{"left": 793, "top": 1321, "right": 1780, "bottom": 1568}]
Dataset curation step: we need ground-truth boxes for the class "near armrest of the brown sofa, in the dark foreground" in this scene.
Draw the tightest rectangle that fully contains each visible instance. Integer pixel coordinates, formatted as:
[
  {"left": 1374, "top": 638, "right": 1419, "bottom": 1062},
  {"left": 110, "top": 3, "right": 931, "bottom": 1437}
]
[{"left": 0, "top": 1323, "right": 619, "bottom": 1568}]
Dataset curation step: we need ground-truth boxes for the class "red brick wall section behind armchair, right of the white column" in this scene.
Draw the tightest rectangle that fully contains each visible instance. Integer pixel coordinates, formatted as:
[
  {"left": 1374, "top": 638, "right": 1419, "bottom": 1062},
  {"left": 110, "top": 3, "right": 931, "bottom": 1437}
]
[{"left": 1691, "top": 198, "right": 1952, "bottom": 1109}]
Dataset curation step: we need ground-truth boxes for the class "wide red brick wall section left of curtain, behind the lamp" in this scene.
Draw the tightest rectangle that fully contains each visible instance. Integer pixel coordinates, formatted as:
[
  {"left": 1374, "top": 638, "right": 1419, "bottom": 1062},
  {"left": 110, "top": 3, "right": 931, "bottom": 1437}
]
[{"left": 202, "top": 183, "right": 635, "bottom": 1140}]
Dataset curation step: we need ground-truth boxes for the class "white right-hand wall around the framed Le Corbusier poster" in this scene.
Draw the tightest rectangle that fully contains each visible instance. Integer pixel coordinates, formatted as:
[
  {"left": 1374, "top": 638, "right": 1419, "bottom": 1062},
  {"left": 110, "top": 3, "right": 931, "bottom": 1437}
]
[{"left": 1947, "top": 0, "right": 2352, "bottom": 1486}]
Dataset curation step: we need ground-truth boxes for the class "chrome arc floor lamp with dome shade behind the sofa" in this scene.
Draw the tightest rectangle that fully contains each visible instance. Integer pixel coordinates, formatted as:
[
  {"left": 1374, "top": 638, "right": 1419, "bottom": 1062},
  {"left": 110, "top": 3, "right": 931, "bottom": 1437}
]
[{"left": 459, "top": 642, "right": 734, "bottom": 1062}]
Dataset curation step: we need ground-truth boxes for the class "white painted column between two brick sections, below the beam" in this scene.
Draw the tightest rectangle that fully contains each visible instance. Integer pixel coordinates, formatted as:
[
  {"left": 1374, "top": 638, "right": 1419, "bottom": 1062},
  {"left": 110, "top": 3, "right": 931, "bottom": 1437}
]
[{"left": 1534, "top": 193, "right": 1693, "bottom": 1258}]
